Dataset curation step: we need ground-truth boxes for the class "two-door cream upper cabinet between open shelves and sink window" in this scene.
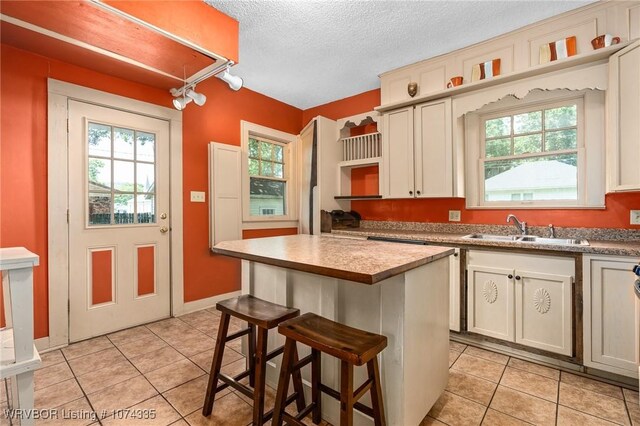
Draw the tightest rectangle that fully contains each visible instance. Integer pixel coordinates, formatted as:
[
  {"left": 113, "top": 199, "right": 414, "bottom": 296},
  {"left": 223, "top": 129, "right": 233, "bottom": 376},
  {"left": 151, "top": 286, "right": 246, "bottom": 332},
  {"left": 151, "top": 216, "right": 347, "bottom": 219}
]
[{"left": 383, "top": 98, "right": 453, "bottom": 198}]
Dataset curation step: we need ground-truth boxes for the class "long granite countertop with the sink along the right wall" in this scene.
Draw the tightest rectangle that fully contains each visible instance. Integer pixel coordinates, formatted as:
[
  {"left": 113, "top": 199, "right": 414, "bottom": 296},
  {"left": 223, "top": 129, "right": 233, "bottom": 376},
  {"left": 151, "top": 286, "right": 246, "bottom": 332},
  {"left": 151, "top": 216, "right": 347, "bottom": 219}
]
[{"left": 332, "top": 227, "right": 640, "bottom": 256}]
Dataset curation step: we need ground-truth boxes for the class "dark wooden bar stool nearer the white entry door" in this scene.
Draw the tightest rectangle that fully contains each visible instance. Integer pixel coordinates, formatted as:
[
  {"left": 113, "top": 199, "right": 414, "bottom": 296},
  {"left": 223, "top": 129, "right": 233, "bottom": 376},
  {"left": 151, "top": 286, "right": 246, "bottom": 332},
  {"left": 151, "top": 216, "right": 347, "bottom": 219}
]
[{"left": 202, "top": 295, "right": 305, "bottom": 425}]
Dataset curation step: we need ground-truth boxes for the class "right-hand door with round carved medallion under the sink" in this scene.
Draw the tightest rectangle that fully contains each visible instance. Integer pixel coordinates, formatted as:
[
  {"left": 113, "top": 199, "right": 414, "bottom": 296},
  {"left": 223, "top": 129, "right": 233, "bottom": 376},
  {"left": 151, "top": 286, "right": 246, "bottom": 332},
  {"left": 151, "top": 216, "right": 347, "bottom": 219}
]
[{"left": 514, "top": 270, "right": 573, "bottom": 356}]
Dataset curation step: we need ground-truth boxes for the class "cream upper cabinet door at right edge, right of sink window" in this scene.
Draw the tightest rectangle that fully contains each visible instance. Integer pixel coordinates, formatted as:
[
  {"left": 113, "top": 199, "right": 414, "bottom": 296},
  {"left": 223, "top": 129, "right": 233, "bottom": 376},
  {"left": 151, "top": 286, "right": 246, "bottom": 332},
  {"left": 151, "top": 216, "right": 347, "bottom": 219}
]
[{"left": 607, "top": 42, "right": 640, "bottom": 191}]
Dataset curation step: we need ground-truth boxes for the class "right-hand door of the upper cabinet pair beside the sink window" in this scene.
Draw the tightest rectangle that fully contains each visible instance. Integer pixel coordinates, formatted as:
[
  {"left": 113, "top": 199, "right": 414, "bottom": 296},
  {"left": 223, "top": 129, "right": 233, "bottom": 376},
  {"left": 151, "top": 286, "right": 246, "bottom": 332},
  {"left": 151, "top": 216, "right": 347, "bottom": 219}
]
[{"left": 414, "top": 98, "right": 453, "bottom": 197}]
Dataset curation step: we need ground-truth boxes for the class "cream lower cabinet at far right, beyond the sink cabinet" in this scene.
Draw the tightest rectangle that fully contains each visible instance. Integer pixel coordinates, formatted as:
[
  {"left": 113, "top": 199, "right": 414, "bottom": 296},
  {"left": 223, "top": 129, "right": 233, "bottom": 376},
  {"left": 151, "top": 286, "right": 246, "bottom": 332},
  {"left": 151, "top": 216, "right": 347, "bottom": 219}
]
[{"left": 583, "top": 256, "right": 640, "bottom": 377}]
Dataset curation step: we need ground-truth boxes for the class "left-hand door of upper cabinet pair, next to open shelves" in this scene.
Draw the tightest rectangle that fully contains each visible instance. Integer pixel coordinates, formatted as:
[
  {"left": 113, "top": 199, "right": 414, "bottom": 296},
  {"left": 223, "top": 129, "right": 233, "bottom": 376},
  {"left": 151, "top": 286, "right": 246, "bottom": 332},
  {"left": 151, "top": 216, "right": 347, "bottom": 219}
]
[{"left": 382, "top": 107, "right": 415, "bottom": 198}]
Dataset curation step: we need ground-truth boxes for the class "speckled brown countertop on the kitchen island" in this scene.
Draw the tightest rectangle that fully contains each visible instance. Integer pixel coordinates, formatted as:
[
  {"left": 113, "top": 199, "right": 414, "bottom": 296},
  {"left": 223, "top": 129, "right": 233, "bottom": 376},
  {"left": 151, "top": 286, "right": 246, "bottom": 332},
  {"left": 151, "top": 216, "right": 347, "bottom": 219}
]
[{"left": 211, "top": 235, "right": 453, "bottom": 284}]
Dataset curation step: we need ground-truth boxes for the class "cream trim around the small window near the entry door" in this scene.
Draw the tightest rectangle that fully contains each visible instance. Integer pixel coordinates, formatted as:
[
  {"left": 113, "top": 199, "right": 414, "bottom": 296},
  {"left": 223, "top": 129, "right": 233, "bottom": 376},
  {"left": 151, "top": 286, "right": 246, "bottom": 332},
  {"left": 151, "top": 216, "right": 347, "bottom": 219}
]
[{"left": 240, "top": 120, "right": 298, "bottom": 223}]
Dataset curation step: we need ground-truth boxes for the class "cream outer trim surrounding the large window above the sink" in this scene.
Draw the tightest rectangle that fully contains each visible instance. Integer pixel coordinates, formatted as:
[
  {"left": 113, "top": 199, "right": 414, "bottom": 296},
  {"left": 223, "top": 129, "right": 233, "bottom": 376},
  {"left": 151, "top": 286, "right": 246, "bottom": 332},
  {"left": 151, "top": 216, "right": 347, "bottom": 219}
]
[{"left": 465, "top": 90, "right": 605, "bottom": 209}]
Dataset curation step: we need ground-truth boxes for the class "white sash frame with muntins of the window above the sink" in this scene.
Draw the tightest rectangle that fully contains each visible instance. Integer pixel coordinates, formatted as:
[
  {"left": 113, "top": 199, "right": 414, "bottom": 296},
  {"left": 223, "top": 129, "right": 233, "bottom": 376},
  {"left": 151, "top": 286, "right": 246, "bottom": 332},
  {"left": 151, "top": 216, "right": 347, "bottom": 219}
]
[{"left": 478, "top": 95, "right": 585, "bottom": 208}]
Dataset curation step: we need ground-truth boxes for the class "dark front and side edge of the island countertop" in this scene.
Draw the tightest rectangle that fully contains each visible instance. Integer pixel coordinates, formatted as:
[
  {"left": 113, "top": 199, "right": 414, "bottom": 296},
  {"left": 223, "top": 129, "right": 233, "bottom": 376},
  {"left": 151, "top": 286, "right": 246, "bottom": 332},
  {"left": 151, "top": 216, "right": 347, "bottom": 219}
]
[{"left": 211, "top": 247, "right": 454, "bottom": 285}]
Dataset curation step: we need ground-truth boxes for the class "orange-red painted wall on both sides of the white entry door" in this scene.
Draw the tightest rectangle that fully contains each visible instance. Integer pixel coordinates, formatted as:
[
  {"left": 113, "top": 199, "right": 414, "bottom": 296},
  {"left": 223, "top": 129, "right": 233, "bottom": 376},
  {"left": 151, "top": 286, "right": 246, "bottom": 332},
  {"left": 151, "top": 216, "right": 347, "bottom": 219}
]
[{"left": 0, "top": 44, "right": 302, "bottom": 338}]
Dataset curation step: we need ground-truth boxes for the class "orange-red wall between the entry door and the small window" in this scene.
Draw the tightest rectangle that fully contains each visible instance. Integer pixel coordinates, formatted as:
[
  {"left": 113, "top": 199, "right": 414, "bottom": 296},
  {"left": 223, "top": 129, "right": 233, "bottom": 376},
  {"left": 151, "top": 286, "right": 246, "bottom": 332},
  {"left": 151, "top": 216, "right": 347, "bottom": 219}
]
[{"left": 183, "top": 78, "right": 302, "bottom": 302}]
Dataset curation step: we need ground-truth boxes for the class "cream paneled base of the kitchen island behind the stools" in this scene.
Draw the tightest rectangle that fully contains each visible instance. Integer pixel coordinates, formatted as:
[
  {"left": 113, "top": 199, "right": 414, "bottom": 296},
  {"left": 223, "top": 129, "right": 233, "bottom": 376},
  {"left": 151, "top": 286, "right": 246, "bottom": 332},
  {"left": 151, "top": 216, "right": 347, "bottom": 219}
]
[{"left": 242, "top": 257, "right": 449, "bottom": 426}]
